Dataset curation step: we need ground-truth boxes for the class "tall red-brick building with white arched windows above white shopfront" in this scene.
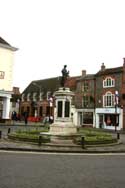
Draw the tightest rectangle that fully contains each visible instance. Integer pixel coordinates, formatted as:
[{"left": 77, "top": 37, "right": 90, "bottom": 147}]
[{"left": 95, "top": 63, "right": 123, "bottom": 130}]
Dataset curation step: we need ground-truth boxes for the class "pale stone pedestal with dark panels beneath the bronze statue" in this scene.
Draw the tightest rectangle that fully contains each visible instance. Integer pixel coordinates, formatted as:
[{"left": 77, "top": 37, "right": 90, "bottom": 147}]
[{"left": 49, "top": 88, "right": 77, "bottom": 143}]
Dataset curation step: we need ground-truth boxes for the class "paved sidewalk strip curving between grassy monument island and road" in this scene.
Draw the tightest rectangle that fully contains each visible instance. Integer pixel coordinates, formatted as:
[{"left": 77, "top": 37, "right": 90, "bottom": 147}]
[{"left": 0, "top": 135, "right": 125, "bottom": 153}]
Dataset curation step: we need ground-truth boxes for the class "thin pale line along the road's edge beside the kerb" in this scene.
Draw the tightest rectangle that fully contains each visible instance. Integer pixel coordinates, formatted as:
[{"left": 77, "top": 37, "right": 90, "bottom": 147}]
[{"left": 0, "top": 150, "right": 125, "bottom": 156}]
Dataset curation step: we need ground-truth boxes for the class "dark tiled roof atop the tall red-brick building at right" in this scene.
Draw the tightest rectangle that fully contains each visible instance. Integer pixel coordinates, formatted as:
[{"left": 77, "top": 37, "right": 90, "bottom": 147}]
[{"left": 95, "top": 67, "right": 123, "bottom": 76}]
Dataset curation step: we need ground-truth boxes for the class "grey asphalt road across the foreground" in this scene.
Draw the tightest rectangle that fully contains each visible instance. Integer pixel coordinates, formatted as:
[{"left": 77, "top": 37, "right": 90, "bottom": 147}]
[{"left": 0, "top": 151, "right": 125, "bottom": 188}]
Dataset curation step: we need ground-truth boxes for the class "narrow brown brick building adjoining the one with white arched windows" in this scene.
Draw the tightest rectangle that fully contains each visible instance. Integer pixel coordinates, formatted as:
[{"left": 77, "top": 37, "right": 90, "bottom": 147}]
[{"left": 75, "top": 70, "right": 95, "bottom": 126}]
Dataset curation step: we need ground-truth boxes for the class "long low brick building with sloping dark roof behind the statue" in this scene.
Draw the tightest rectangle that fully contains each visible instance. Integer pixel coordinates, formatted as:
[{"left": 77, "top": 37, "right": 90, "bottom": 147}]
[{"left": 20, "top": 77, "right": 78, "bottom": 121}]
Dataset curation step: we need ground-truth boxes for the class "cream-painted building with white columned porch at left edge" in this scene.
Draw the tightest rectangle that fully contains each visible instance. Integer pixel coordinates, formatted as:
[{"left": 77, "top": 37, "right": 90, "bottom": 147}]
[{"left": 0, "top": 37, "right": 17, "bottom": 120}]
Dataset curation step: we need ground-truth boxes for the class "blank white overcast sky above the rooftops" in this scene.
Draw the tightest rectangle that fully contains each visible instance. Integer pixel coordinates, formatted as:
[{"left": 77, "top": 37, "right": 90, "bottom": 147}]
[{"left": 0, "top": 0, "right": 125, "bottom": 92}]
